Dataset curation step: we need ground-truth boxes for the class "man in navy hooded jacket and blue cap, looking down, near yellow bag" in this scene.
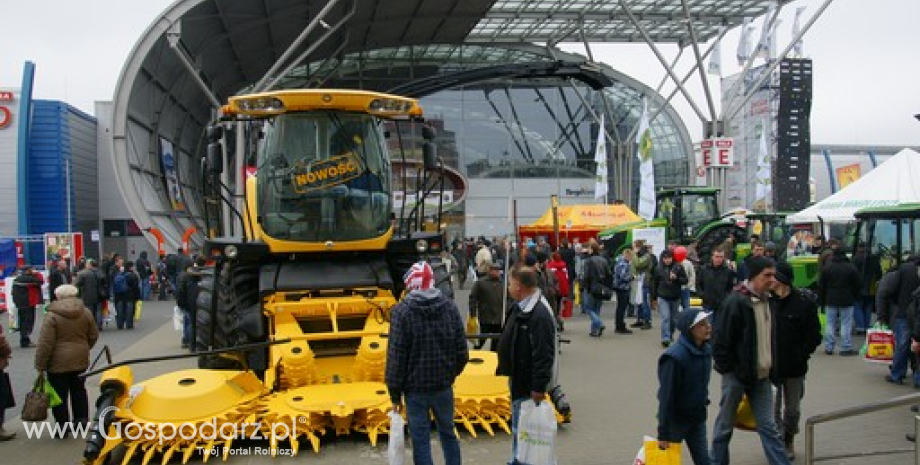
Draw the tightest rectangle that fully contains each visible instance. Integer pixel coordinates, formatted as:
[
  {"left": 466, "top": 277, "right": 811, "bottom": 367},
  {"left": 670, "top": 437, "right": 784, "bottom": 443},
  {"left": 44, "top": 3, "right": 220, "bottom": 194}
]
[{"left": 658, "top": 309, "right": 712, "bottom": 465}]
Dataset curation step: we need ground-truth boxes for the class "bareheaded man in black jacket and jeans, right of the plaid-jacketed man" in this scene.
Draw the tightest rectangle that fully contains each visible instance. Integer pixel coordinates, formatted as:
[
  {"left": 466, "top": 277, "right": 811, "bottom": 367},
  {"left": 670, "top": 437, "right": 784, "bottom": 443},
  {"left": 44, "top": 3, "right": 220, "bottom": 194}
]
[{"left": 496, "top": 267, "right": 556, "bottom": 463}]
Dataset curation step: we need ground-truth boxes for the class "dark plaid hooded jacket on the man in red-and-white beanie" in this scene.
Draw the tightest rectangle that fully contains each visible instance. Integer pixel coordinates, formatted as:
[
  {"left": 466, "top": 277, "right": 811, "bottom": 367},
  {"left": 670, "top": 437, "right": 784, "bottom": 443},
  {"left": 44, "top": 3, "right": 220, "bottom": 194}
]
[{"left": 385, "top": 289, "right": 469, "bottom": 404}]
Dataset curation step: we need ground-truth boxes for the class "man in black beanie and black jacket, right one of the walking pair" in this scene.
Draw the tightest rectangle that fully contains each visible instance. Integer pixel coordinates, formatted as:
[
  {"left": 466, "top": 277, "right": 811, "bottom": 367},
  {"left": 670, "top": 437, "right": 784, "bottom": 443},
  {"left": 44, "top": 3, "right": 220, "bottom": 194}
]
[{"left": 770, "top": 262, "right": 821, "bottom": 460}]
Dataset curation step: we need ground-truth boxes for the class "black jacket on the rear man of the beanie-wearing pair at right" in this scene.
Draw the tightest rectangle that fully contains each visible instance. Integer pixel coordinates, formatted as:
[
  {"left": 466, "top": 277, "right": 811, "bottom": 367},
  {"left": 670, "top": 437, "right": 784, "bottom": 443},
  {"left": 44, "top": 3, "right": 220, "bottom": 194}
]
[{"left": 770, "top": 288, "right": 821, "bottom": 383}]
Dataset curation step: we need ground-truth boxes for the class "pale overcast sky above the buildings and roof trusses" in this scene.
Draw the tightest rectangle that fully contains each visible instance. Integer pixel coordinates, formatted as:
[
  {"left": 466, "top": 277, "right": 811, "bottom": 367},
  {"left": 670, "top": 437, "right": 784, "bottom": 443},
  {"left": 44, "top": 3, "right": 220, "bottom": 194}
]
[{"left": 0, "top": 0, "right": 920, "bottom": 145}]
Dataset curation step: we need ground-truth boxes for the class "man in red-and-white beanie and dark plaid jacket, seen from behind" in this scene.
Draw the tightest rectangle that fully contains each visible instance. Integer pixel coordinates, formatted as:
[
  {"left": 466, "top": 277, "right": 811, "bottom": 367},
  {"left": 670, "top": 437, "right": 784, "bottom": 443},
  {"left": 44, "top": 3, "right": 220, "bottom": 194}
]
[{"left": 385, "top": 262, "right": 469, "bottom": 465}]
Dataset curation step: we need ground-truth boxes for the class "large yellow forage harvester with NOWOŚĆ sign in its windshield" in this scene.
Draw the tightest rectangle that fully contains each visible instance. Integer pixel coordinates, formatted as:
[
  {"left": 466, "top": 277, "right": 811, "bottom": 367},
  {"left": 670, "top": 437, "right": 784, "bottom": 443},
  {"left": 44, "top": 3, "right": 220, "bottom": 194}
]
[{"left": 84, "top": 89, "right": 511, "bottom": 464}]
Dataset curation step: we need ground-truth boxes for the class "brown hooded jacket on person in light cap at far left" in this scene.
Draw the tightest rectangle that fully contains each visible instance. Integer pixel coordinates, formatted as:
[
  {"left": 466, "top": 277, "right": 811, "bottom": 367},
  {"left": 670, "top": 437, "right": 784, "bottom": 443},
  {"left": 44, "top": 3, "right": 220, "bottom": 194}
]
[{"left": 35, "top": 297, "right": 99, "bottom": 373}]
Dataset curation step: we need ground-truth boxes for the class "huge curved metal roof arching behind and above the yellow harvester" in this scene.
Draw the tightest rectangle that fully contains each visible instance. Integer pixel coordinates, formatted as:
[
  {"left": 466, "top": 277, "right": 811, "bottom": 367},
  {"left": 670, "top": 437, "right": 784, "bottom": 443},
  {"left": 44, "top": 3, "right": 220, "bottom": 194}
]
[{"left": 112, "top": 0, "right": 788, "bottom": 247}]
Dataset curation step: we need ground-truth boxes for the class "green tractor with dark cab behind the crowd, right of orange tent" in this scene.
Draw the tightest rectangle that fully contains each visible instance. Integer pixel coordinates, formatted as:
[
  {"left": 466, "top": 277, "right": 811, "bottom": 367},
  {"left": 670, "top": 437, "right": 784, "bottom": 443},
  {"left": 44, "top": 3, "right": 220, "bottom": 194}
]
[{"left": 598, "top": 187, "right": 746, "bottom": 261}]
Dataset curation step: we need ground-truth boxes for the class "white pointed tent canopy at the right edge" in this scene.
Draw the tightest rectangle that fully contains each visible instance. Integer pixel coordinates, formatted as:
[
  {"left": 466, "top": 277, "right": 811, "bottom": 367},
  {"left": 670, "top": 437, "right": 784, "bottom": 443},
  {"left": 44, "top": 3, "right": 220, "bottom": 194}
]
[{"left": 786, "top": 149, "right": 920, "bottom": 223}]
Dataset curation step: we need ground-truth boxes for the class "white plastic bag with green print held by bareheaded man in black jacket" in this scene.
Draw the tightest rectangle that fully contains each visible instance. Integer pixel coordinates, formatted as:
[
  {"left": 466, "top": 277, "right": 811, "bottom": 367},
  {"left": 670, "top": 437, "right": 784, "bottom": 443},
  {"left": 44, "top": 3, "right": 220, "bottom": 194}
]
[{"left": 515, "top": 399, "right": 557, "bottom": 465}]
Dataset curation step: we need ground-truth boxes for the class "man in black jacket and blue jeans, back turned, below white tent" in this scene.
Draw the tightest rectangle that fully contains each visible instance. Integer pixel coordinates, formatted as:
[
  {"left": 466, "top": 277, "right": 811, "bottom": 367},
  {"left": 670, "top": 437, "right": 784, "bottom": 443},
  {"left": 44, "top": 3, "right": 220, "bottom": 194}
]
[{"left": 818, "top": 248, "right": 862, "bottom": 356}]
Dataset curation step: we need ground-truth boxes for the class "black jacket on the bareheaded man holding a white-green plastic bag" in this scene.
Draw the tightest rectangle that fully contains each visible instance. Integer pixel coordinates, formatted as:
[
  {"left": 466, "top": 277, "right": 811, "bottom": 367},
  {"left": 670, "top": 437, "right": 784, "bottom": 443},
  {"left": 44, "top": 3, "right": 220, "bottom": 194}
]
[{"left": 495, "top": 291, "right": 556, "bottom": 400}]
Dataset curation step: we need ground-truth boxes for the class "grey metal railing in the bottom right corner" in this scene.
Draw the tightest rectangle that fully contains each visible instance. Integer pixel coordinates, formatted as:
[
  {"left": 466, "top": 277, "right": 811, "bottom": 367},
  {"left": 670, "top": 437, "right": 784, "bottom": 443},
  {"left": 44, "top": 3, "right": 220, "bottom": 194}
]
[{"left": 805, "top": 393, "right": 920, "bottom": 465}]
